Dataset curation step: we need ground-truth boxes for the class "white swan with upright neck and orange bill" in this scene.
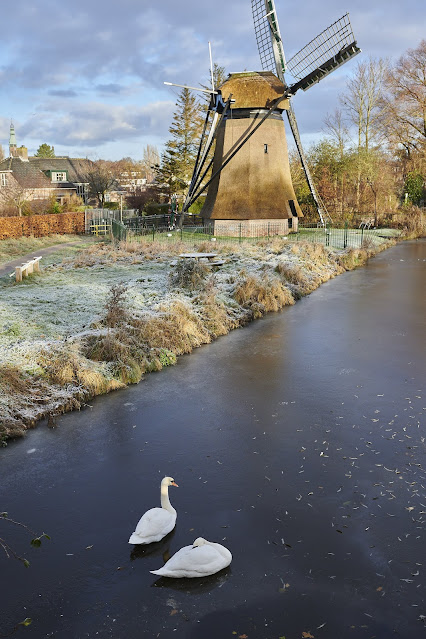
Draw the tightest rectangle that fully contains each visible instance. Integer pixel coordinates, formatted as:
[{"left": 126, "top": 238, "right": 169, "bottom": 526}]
[{"left": 129, "top": 477, "right": 177, "bottom": 544}]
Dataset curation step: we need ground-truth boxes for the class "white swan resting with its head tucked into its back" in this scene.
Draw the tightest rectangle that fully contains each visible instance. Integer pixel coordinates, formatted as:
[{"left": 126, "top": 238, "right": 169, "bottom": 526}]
[{"left": 150, "top": 537, "right": 232, "bottom": 578}]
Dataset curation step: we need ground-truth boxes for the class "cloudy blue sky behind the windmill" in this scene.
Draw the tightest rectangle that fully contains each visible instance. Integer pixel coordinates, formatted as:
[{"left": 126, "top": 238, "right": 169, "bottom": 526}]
[{"left": 0, "top": 0, "right": 426, "bottom": 160}]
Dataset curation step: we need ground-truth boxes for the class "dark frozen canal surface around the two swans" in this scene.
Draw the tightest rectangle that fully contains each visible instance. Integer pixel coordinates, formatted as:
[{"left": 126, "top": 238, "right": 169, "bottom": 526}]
[{"left": 0, "top": 240, "right": 426, "bottom": 639}]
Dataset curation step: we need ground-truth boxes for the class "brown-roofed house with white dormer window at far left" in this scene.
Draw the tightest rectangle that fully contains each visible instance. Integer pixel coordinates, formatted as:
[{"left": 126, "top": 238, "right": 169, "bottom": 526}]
[{"left": 0, "top": 124, "right": 93, "bottom": 204}]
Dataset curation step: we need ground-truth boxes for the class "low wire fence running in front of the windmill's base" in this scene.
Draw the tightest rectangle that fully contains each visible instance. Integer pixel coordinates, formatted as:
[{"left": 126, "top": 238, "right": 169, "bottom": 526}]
[{"left": 111, "top": 220, "right": 400, "bottom": 249}]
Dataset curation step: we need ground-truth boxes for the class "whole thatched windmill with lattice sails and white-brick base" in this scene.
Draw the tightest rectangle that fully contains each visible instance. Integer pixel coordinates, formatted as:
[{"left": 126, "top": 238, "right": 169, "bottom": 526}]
[{"left": 176, "top": 5, "right": 360, "bottom": 235}]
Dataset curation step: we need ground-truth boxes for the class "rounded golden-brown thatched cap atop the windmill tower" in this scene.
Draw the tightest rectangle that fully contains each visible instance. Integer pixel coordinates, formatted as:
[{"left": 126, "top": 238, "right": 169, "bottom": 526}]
[{"left": 219, "top": 71, "right": 289, "bottom": 109}]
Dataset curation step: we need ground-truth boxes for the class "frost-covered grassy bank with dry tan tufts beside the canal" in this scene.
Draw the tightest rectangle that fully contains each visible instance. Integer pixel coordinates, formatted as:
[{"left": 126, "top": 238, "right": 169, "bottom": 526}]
[{"left": 0, "top": 238, "right": 396, "bottom": 442}]
